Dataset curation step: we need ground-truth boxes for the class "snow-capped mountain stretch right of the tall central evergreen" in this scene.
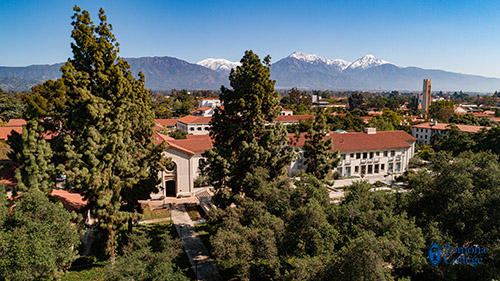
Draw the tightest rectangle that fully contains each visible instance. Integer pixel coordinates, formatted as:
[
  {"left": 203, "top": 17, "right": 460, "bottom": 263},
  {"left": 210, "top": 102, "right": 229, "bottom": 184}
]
[{"left": 271, "top": 53, "right": 500, "bottom": 92}]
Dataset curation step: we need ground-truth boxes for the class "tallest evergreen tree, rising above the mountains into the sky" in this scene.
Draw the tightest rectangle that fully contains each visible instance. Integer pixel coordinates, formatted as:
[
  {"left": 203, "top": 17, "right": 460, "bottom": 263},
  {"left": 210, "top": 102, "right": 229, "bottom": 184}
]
[{"left": 61, "top": 6, "right": 162, "bottom": 261}]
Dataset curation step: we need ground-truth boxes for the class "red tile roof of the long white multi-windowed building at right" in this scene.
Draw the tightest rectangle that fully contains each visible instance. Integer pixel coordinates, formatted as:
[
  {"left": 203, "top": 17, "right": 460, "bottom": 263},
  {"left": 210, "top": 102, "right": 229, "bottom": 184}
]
[{"left": 288, "top": 131, "right": 415, "bottom": 152}]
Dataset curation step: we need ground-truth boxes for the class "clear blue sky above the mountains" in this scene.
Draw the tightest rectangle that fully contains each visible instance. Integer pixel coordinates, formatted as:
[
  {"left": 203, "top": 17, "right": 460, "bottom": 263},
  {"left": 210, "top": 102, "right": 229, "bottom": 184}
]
[{"left": 0, "top": 0, "right": 500, "bottom": 78}]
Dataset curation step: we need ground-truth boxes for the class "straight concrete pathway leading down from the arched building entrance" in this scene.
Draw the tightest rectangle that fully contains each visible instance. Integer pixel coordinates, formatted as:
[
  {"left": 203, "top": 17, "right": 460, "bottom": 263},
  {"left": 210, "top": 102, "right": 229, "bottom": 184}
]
[{"left": 170, "top": 204, "right": 222, "bottom": 281}]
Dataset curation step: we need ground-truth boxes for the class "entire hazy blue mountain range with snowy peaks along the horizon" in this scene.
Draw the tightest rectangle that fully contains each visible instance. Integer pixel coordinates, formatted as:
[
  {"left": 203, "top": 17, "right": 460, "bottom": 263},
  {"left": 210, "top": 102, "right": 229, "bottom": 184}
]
[{"left": 0, "top": 52, "right": 500, "bottom": 92}]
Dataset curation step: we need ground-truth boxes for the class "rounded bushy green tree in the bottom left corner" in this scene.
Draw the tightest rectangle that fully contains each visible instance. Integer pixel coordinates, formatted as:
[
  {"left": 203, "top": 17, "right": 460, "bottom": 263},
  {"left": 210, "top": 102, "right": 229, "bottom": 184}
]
[{"left": 0, "top": 189, "right": 80, "bottom": 280}]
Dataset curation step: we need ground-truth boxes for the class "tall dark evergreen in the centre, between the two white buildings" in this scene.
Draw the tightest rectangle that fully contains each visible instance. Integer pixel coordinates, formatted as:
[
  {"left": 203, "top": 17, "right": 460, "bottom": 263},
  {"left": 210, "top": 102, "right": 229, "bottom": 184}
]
[{"left": 204, "top": 51, "right": 291, "bottom": 204}]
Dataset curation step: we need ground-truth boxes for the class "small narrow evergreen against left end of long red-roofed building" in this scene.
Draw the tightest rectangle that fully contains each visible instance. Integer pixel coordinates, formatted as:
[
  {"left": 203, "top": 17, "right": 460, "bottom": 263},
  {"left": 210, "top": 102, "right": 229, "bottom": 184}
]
[{"left": 303, "top": 111, "right": 340, "bottom": 179}]
